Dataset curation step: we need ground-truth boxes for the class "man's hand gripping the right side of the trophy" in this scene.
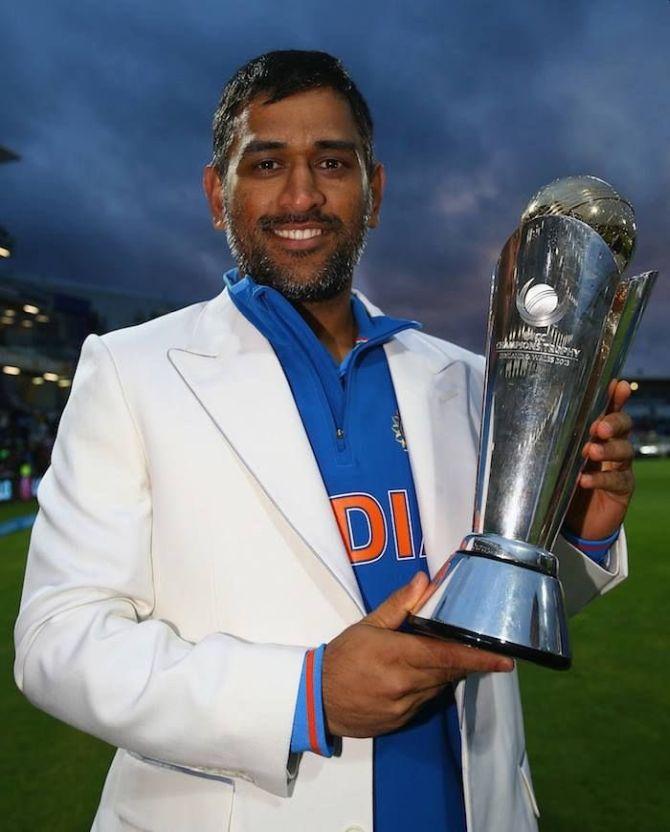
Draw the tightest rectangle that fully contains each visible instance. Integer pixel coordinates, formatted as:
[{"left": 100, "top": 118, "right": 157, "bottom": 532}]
[{"left": 565, "top": 381, "right": 635, "bottom": 540}]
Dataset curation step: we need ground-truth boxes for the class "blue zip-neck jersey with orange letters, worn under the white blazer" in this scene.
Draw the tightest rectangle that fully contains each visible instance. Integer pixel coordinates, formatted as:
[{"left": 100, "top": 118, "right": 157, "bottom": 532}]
[{"left": 227, "top": 272, "right": 465, "bottom": 832}]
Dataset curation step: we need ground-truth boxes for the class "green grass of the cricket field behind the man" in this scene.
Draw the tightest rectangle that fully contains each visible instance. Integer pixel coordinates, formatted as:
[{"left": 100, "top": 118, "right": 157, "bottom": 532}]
[{"left": 0, "top": 460, "right": 670, "bottom": 832}]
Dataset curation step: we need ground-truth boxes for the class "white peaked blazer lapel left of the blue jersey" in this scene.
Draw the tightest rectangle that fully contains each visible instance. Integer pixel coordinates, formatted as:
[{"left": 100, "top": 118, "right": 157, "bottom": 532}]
[{"left": 168, "top": 290, "right": 365, "bottom": 613}]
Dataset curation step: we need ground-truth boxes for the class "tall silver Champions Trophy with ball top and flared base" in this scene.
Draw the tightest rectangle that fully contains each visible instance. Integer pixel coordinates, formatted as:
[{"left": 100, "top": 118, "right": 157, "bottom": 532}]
[{"left": 408, "top": 176, "right": 657, "bottom": 669}]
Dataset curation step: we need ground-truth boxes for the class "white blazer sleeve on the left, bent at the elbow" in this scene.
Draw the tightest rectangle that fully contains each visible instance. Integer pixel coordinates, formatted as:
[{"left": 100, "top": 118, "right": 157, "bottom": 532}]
[{"left": 15, "top": 335, "right": 305, "bottom": 796}]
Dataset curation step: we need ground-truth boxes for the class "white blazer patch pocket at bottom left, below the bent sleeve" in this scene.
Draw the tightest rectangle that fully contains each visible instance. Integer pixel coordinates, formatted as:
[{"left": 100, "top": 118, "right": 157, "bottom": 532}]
[{"left": 111, "top": 751, "right": 235, "bottom": 832}]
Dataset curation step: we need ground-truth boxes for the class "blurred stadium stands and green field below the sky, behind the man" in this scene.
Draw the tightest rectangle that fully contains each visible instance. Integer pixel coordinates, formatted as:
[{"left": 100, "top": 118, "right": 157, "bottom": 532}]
[{"left": 0, "top": 138, "right": 670, "bottom": 832}]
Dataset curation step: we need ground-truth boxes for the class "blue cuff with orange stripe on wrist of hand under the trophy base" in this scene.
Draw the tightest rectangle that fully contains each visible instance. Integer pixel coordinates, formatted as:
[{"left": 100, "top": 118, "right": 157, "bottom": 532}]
[{"left": 291, "top": 644, "right": 334, "bottom": 757}]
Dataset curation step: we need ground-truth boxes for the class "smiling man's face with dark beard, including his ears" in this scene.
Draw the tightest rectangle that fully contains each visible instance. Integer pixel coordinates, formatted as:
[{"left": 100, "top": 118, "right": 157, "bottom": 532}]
[{"left": 205, "top": 89, "right": 383, "bottom": 301}]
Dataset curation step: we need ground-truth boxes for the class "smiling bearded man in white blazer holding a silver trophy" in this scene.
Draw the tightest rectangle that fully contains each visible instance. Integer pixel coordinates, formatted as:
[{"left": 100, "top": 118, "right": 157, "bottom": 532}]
[{"left": 16, "top": 52, "right": 632, "bottom": 832}]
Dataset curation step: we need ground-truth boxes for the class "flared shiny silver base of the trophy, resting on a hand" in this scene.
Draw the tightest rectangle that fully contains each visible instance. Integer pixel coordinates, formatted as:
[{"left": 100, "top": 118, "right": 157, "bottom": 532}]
[{"left": 407, "top": 533, "right": 571, "bottom": 670}]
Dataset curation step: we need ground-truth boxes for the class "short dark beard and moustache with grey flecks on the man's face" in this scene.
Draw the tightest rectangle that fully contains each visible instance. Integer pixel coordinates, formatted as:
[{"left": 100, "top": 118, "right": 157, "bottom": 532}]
[{"left": 224, "top": 190, "right": 372, "bottom": 303}]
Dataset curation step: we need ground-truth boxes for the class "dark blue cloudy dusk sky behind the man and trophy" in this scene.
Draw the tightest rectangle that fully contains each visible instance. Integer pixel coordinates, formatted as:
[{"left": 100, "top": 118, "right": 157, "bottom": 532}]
[{"left": 0, "top": 0, "right": 670, "bottom": 376}]
